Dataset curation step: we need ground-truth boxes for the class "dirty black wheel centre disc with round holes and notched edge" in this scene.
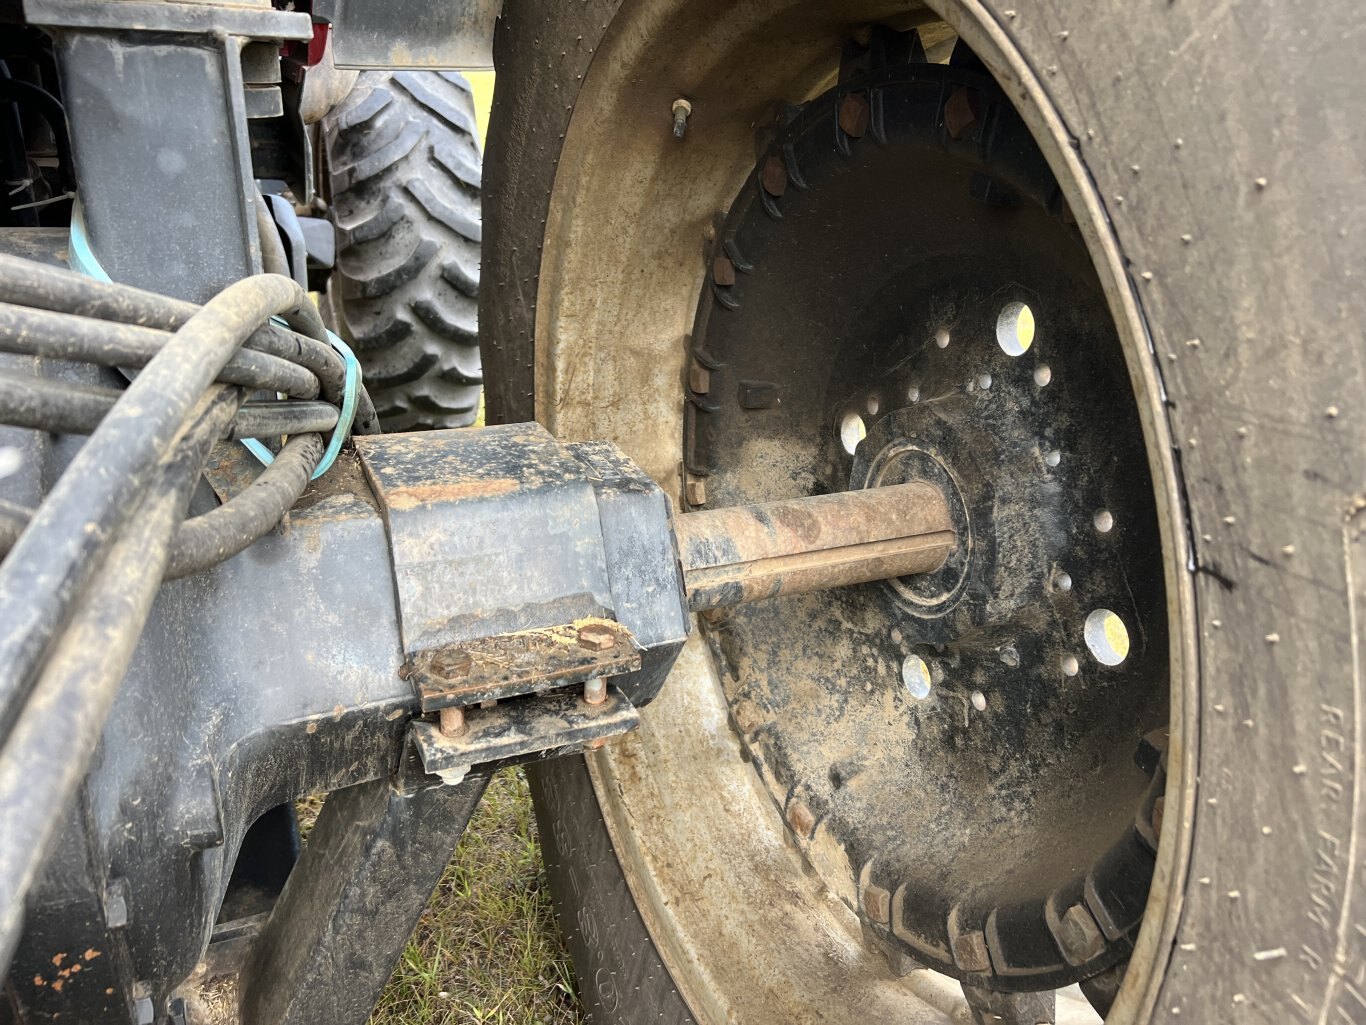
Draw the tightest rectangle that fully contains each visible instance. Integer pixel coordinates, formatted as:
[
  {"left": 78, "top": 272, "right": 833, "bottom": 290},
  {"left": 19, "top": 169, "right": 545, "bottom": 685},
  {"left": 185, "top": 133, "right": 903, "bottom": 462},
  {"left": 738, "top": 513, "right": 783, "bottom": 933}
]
[{"left": 684, "top": 64, "right": 1169, "bottom": 989}]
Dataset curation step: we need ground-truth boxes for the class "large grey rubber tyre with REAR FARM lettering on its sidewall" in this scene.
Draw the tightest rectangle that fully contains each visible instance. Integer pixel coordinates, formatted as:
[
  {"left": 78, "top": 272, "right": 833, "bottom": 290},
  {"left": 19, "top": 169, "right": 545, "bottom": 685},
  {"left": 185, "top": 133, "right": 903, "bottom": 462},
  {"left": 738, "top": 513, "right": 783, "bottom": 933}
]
[{"left": 485, "top": 0, "right": 1366, "bottom": 1025}]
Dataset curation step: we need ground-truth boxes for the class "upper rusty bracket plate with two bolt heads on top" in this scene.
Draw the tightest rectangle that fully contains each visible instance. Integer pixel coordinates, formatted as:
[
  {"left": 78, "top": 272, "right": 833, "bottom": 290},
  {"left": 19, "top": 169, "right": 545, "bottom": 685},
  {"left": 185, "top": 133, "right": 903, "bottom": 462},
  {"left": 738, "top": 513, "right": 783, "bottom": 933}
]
[{"left": 403, "top": 618, "right": 641, "bottom": 712}]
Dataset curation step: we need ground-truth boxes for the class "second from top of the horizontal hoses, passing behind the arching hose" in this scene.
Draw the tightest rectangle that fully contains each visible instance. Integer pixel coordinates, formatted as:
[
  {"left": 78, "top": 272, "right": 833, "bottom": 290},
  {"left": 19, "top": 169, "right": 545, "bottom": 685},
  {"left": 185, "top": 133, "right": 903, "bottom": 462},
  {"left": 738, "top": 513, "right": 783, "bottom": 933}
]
[{"left": 0, "top": 302, "right": 318, "bottom": 399}]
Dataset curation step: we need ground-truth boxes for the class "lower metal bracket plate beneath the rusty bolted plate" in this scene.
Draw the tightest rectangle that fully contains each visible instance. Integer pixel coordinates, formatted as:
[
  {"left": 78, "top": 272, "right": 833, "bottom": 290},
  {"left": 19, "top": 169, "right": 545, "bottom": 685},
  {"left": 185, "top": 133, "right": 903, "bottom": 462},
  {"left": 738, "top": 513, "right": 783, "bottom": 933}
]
[{"left": 411, "top": 686, "right": 641, "bottom": 775}]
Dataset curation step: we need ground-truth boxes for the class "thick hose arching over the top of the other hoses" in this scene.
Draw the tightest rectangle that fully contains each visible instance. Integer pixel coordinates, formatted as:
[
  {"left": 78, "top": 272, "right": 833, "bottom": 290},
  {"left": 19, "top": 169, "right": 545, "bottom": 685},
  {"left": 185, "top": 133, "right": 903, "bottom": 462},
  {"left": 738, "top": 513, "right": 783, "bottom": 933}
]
[{"left": 0, "top": 273, "right": 310, "bottom": 738}]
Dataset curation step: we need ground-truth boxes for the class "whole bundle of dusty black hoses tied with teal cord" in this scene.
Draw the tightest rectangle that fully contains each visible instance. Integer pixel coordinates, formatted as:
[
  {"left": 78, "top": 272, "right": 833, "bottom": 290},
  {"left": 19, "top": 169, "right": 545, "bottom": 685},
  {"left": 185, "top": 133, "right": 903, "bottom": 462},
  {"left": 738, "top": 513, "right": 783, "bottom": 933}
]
[{"left": 0, "top": 256, "right": 377, "bottom": 970}]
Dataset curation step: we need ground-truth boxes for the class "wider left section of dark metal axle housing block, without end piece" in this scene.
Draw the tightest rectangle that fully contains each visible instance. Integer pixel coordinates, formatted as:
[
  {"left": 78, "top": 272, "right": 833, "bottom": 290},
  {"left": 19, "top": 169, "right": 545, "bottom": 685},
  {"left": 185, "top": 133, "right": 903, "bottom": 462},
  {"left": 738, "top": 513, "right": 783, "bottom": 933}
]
[{"left": 357, "top": 424, "right": 612, "bottom": 653}]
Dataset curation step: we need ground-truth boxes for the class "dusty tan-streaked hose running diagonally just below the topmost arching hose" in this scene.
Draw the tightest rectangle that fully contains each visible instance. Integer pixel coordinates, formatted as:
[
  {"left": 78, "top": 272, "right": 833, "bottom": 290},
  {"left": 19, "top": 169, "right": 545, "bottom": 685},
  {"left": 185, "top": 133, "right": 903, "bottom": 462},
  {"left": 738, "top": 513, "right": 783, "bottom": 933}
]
[{"left": 0, "top": 385, "right": 242, "bottom": 965}]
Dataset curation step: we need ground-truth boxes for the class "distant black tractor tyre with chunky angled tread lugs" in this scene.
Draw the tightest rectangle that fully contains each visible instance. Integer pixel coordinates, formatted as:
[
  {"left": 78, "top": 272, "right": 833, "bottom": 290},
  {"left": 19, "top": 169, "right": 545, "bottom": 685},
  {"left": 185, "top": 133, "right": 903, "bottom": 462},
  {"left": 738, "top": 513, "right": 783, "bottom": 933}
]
[{"left": 324, "top": 71, "right": 482, "bottom": 431}]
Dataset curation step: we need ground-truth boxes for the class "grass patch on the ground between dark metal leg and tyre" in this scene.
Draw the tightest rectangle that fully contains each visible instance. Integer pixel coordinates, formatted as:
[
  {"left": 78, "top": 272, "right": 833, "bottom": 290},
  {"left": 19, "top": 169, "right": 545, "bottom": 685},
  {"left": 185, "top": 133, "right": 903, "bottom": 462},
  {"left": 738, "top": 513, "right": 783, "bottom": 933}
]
[{"left": 370, "top": 768, "right": 582, "bottom": 1025}]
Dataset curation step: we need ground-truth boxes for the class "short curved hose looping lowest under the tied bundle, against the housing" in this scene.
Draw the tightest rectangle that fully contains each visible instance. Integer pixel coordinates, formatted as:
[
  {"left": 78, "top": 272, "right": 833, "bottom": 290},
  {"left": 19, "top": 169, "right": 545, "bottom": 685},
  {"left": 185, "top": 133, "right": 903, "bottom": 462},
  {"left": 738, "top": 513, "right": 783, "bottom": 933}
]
[{"left": 163, "top": 435, "right": 324, "bottom": 579}]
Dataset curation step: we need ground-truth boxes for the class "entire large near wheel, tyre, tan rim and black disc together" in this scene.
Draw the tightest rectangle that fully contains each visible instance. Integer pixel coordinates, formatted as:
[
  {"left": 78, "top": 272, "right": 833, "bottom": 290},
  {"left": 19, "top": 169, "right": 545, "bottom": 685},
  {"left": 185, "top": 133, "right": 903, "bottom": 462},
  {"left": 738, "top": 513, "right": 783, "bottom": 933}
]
[{"left": 482, "top": 0, "right": 1366, "bottom": 1025}]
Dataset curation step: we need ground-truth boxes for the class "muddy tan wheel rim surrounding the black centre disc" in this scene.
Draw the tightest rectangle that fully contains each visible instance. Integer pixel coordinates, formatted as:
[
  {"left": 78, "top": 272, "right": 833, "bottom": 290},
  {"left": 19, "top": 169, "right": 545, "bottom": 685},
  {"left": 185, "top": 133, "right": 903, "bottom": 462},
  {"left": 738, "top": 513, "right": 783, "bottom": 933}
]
[{"left": 538, "top": 3, "right": 1191, "bottom": 1021}]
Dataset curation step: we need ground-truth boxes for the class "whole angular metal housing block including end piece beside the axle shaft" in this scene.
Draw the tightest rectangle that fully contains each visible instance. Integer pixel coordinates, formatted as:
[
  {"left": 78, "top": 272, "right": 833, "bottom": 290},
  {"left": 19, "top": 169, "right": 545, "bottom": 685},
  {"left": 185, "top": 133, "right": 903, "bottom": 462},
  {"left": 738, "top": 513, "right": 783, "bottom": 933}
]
[{"left": 355, "top": 424, "right": 690, "bottom": 705}]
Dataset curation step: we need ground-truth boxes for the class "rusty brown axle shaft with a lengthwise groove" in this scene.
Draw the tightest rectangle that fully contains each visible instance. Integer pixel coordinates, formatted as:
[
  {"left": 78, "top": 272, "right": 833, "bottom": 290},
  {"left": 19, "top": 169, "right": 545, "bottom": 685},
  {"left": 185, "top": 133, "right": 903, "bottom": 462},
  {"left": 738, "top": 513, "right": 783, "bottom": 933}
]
[{"left": 673, "top": 481, "right": 958, "bottom": 612}]
